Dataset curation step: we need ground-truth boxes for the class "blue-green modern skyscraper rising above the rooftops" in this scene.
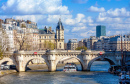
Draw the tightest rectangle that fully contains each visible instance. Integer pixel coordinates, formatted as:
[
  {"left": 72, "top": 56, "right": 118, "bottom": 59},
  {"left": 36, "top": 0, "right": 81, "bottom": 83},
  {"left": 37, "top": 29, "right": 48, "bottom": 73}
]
[{"left": 96, "top": 25, "right": 106, "bottom": 37}]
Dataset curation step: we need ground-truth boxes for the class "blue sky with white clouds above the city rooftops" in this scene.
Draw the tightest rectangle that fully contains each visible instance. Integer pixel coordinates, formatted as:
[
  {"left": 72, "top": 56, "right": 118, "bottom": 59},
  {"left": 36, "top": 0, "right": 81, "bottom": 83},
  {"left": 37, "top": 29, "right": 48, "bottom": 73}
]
[{"left": 0, "top": 0, "right": 130, "bottom": 42}]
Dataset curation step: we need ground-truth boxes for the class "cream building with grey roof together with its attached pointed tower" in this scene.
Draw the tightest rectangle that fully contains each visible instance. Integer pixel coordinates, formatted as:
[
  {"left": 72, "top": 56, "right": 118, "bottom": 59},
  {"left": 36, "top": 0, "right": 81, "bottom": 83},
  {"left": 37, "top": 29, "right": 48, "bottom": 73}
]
[{"left": 39, "top": 19, "right": 64, "bottom": 50}]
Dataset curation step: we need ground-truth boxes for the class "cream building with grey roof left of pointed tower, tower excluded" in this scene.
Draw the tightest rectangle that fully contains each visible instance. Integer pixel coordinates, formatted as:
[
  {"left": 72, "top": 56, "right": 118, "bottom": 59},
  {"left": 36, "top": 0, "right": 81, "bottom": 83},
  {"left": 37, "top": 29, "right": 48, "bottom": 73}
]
[{"left": 39, "top": 26, "right": 56, "bottom": 50}]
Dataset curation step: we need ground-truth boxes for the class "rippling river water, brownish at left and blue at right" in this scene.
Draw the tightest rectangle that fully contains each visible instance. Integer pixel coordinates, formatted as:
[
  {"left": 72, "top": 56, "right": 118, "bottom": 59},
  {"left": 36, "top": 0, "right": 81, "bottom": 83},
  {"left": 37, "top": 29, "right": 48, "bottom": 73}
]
[{"left": 0, "top": 61, "right": 119, "bottom": 84}]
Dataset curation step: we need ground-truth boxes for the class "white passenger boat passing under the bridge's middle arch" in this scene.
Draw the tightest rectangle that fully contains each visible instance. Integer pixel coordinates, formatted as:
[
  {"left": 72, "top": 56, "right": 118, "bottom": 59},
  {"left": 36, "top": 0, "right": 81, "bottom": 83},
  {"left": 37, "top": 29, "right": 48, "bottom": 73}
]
[{"left": 63, "top": 63, "right": 77, "bottom": 72}]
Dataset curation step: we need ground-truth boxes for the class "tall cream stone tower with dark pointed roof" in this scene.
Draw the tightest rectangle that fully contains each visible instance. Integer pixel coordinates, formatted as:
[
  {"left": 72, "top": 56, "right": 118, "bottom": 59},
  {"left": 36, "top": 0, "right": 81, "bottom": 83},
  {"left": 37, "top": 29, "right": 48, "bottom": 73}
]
[{"left": 56, "top": 19, "right": 64, "bottom": 49}]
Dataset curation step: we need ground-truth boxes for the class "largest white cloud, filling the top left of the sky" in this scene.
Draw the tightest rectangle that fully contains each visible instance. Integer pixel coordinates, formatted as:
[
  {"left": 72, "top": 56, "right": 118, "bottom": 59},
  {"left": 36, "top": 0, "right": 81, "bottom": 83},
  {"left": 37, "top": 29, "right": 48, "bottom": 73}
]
[{"left": 1, "top": 0, "right": 69, "bottom": 14}]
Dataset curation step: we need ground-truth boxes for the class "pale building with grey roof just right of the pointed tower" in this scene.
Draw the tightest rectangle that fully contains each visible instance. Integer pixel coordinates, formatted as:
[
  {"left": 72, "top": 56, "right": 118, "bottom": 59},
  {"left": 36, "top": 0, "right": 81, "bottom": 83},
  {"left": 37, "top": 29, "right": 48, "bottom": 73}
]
[{"left": 67, "top": 39, "right": 78, "bottom": 50}]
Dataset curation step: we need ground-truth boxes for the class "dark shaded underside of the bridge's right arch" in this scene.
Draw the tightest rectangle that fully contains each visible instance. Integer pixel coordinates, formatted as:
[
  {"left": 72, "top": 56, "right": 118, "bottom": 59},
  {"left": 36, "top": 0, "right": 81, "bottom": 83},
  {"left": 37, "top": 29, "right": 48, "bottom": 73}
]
[{"left": 87, "top": 57, "right": 116, "bottom": 70}]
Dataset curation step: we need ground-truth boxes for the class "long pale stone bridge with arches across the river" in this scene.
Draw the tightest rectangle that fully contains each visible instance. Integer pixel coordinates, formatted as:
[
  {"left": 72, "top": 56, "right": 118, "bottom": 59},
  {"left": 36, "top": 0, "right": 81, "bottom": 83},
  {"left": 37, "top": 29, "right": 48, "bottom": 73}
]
[{"left": 0, "top": 50, "right": 130, "bottom": 72}]
